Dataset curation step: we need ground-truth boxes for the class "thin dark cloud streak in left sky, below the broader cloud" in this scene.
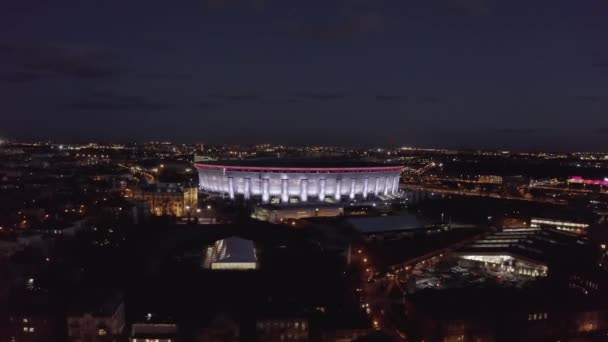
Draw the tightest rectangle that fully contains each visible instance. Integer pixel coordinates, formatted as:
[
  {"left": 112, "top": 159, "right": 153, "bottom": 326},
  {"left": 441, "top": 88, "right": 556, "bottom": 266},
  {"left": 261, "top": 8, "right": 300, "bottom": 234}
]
[{"left": 70, "top": 92, "right": 171, "bottom": 111}]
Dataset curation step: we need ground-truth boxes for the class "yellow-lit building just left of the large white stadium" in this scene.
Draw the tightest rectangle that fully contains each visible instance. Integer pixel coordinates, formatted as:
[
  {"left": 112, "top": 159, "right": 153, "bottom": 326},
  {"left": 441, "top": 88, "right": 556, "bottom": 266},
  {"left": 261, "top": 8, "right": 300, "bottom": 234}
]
[{"left": 131, "top": 183, "right": 198, "bottom": 217}]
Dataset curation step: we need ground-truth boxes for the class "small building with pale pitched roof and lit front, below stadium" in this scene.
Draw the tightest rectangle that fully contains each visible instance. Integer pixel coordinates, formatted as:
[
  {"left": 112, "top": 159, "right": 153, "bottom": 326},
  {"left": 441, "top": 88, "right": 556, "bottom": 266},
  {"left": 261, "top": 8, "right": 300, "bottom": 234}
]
[{"left": 203, "top": 236, "right": 258, "bottom": 270}]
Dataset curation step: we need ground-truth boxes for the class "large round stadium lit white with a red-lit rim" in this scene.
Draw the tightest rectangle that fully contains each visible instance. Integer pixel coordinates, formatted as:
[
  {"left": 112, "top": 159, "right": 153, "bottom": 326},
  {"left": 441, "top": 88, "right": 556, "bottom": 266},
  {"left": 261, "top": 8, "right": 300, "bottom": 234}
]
[{"left": 196, "top": 159, "right": 402, "bottom": 203}]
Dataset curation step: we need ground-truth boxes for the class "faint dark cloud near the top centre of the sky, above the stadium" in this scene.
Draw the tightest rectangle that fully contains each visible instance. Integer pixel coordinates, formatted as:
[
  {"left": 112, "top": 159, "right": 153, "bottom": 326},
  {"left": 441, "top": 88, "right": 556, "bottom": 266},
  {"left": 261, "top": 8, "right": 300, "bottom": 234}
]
[{"left": 282, "top": 12, "right": 385, "bottom": 41}]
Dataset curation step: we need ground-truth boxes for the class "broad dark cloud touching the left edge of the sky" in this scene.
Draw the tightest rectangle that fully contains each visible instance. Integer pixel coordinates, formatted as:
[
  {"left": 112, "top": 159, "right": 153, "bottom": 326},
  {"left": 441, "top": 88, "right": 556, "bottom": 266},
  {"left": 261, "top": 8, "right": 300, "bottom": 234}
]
[{"left": 0, "top": 43, "right": 122, "bottom": 80}]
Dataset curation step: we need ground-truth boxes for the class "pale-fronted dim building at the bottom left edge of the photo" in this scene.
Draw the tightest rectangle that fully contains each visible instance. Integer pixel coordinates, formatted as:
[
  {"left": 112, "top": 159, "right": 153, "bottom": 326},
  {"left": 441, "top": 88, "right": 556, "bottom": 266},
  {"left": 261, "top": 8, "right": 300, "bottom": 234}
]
[{"left": 67, "top": 292, "right": 125, "bottom": 342}]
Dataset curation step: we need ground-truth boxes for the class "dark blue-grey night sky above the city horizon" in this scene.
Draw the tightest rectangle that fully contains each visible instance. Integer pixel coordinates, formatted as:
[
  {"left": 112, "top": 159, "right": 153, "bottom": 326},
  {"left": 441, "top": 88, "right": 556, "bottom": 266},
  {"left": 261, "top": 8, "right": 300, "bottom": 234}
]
[{"left": 0, "top": 0, "right": 608, "bottom": 151}]
